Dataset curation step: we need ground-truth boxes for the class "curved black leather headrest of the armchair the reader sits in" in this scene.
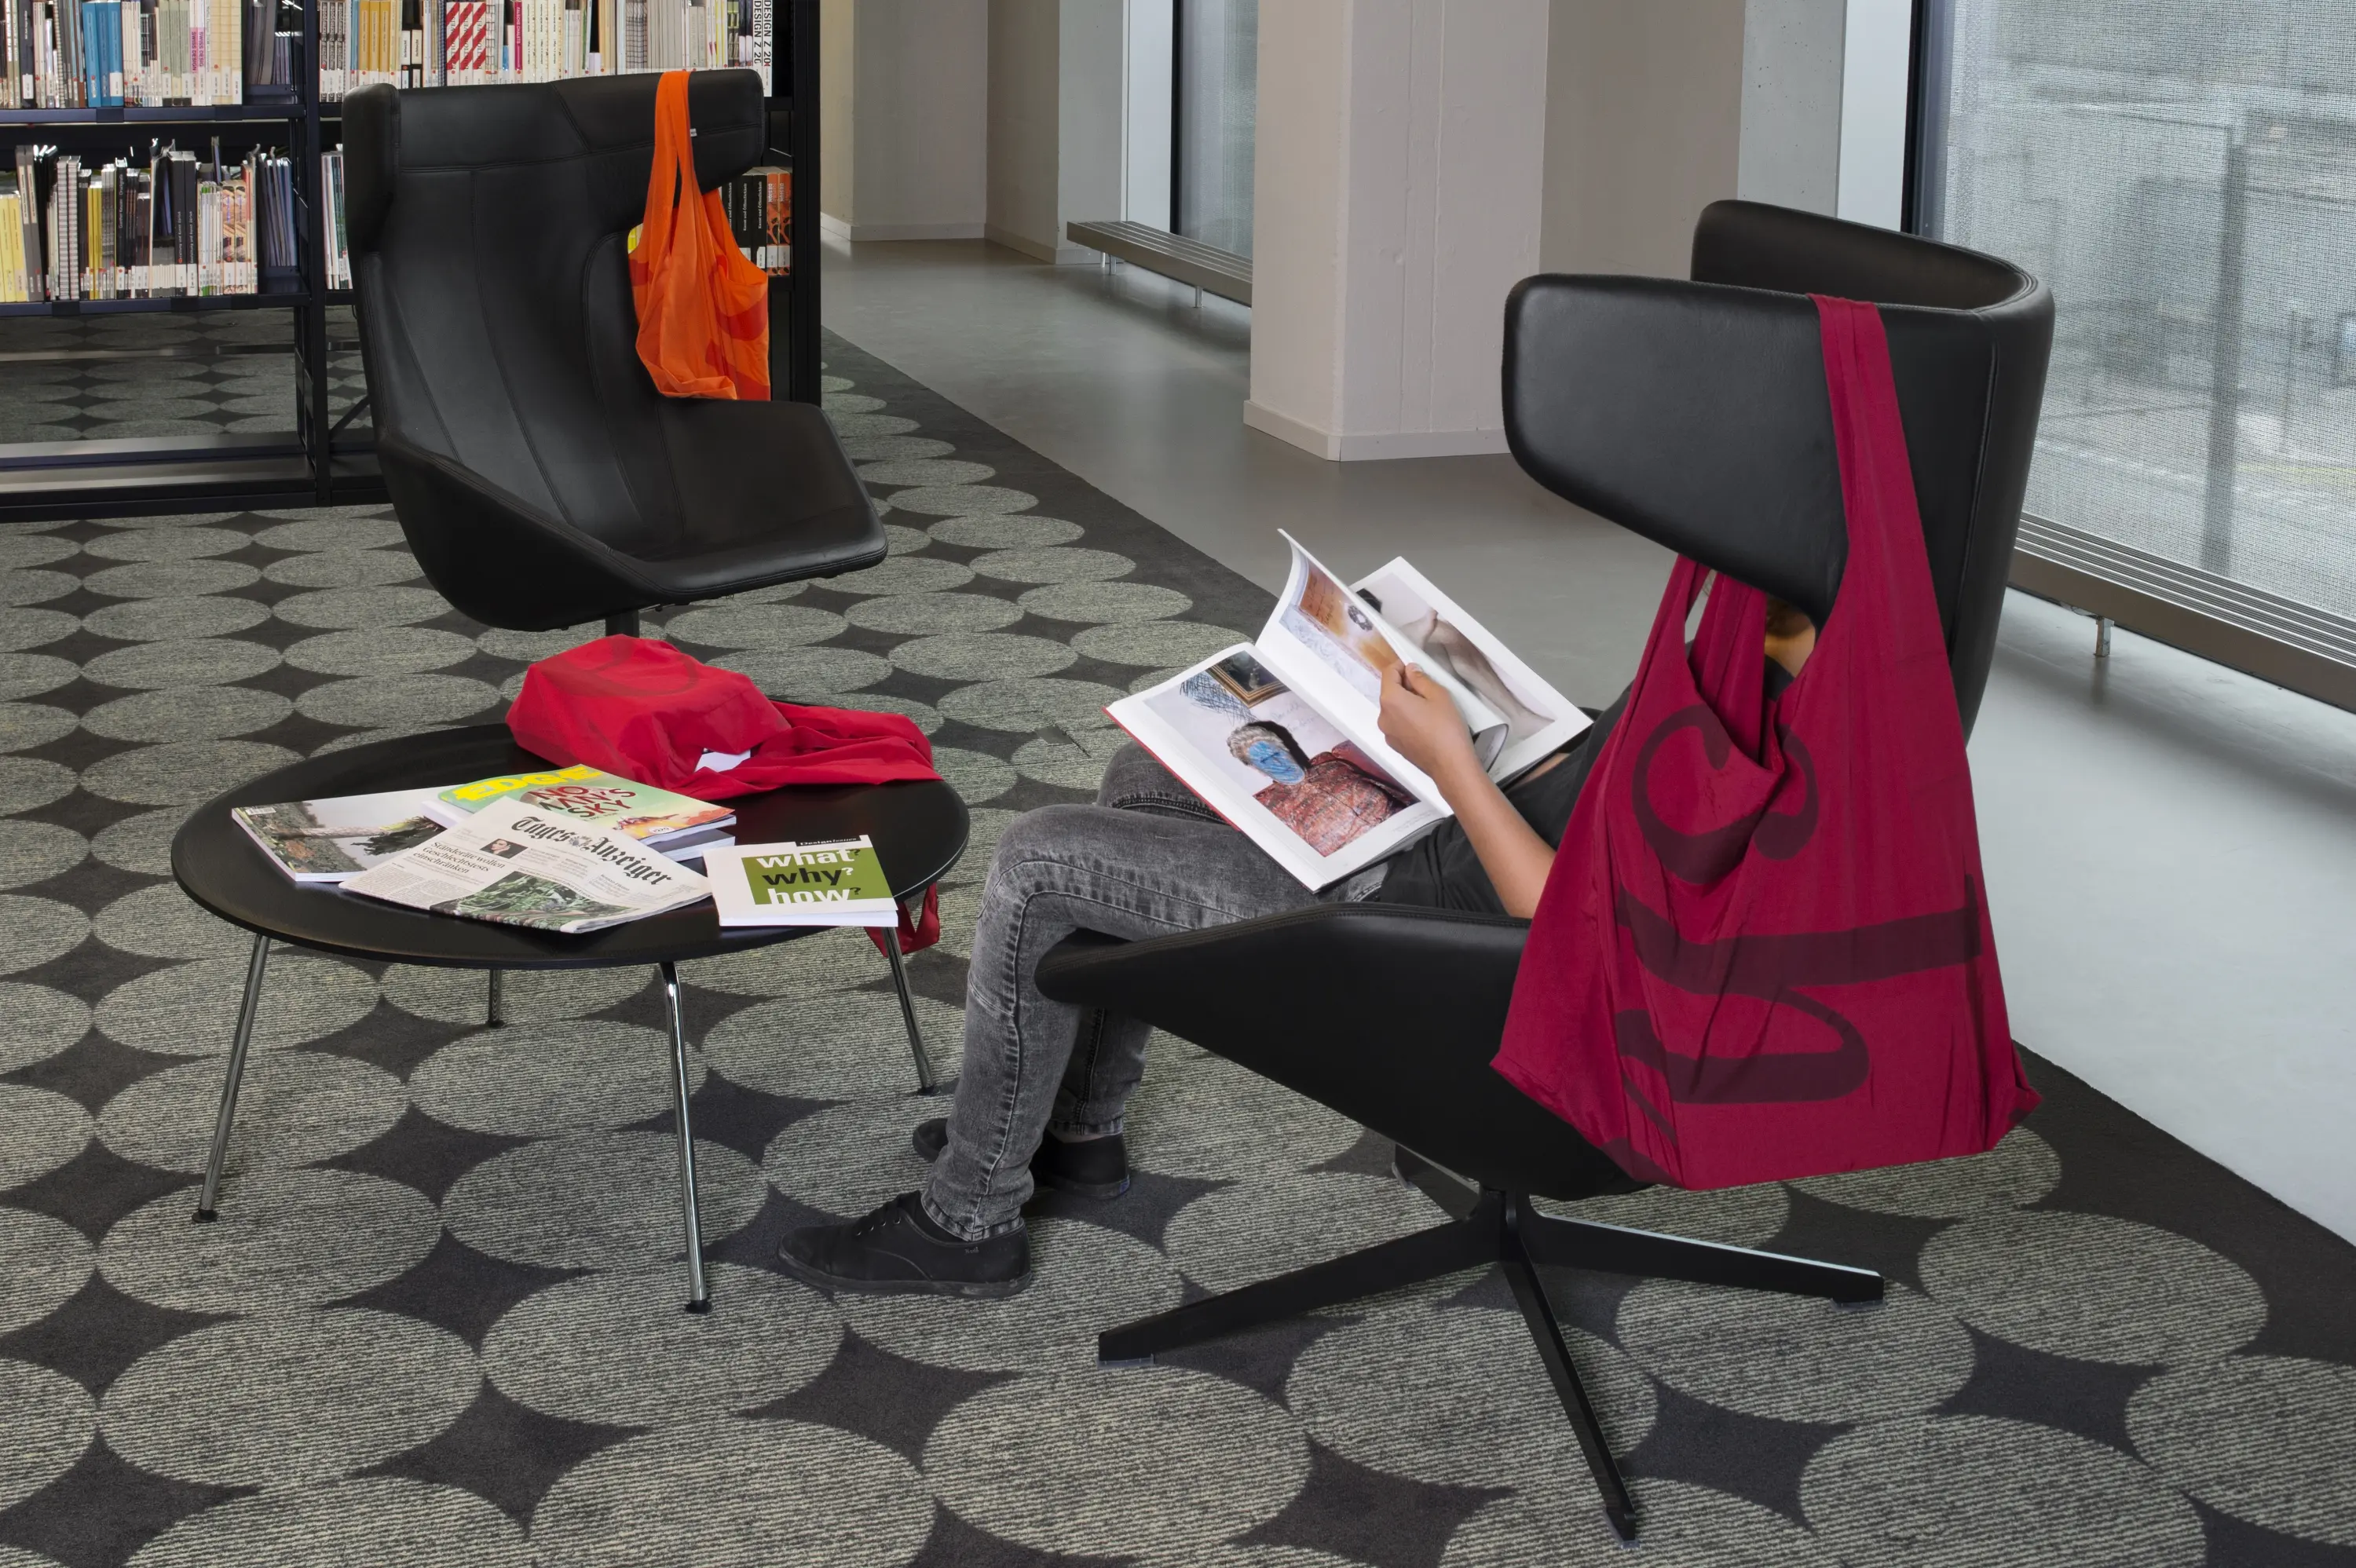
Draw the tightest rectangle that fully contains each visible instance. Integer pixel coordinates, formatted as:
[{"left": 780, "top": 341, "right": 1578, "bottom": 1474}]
[{"left": 1503, "top": 203, "right": 2052, "bottom": 645}]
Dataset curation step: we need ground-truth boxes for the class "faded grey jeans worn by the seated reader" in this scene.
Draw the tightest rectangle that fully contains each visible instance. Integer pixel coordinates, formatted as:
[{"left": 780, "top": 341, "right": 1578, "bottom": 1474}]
[{"left": 924, "top": 747, "right": 1381, "bottom": 1241}]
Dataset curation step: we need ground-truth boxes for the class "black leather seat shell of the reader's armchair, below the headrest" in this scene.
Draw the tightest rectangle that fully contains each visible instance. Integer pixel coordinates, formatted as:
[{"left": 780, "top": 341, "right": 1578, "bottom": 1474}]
[{"left": 1039, "top": 904, "right": 1628, "bottom": 1198}]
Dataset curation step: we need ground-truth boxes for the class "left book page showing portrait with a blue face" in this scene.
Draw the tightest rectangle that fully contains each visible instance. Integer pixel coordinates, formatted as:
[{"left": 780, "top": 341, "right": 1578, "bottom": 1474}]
[{"left": 1105, "top": 645, "right": 1447, "bottom": 887}]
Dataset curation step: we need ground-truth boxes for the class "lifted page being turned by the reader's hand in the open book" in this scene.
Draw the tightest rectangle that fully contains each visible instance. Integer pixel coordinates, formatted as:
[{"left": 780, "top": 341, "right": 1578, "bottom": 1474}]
[{"left": 1260, "top": 530, "right": 1508, "bottom": 777}]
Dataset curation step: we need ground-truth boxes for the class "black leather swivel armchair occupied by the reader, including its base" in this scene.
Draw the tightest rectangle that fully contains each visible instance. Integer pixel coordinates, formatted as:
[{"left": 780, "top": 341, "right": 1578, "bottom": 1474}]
[{"left": 1039, "top": 203, "right": 2052, "bottom": 1540}]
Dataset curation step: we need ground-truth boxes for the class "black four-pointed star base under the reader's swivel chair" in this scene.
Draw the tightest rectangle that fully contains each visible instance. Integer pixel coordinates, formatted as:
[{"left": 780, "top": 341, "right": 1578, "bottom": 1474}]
[{"left": 1096, "top": 1149, "right": 1882, "bottom": 1540}]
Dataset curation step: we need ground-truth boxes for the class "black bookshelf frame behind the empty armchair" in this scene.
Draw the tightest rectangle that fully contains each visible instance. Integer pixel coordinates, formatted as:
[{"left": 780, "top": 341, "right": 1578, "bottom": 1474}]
[{"left": 0, "top": 0, "right": 820, "bottom": 521}]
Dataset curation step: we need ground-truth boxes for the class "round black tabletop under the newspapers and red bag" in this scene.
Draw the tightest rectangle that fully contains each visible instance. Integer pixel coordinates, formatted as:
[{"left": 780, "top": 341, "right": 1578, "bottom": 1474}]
[{"left": 172, "top": 726, "right": 966, "bottom": 970}]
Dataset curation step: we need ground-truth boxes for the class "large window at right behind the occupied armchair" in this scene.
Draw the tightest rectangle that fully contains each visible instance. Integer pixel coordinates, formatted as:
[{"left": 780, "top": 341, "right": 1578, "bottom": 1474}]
[{"left": 1918, "top": 0, "right": 2356, "bottom": 617}]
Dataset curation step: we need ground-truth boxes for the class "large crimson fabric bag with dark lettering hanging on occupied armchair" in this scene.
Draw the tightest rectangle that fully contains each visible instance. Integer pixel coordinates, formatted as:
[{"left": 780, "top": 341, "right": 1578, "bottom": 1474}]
[{"left": 1496, "top": 297, "right": 2038, "bottom": 1186}]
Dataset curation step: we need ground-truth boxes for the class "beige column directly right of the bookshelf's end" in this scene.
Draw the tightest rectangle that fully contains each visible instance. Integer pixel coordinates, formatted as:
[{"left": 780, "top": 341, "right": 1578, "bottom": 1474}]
[{"left": 820, "top": 0, "right": 990, "bottom": 243}]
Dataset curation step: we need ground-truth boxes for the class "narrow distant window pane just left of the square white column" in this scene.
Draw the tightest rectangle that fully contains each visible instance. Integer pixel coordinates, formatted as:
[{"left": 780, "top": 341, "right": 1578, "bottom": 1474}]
[{"left": 1171, "top": 0, "right": 1260, "bottom": 257}]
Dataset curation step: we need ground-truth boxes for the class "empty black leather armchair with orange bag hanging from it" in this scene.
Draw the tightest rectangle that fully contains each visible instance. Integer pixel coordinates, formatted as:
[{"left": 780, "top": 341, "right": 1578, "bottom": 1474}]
[{"left": 344, "top": 71, "right": 884, "bottom": 631}]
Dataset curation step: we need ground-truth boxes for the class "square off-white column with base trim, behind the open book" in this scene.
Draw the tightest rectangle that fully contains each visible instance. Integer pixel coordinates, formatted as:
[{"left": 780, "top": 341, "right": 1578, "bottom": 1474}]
[{"left": 1244, "top": 0, "right": 1548, "bottom": 459}]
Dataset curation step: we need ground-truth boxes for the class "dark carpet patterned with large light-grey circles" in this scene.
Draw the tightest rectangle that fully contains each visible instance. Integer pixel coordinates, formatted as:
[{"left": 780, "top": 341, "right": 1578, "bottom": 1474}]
[{"left": 0, "top": 331, "right": 2356, "bottom": 1568}]
